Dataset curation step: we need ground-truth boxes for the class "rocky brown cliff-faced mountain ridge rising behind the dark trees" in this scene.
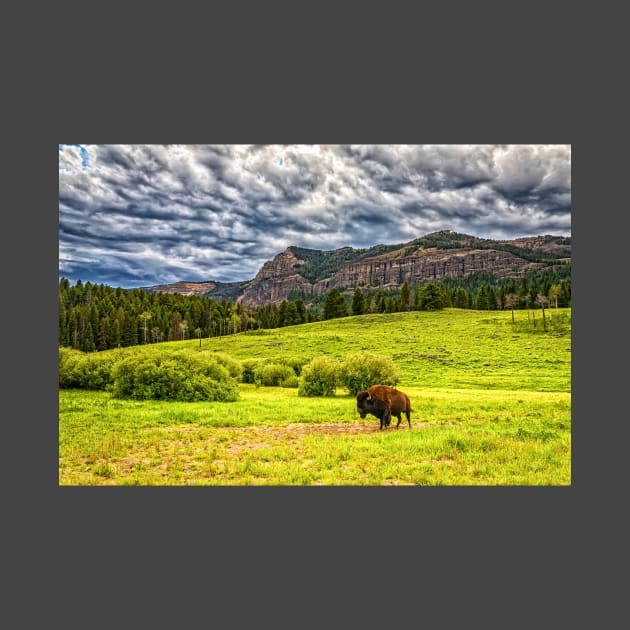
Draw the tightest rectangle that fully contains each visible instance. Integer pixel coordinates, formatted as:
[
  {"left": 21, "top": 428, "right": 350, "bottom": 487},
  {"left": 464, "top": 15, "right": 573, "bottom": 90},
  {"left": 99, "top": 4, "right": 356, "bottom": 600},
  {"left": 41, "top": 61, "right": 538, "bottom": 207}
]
[{"left": 139, "top": 230, "right": 571, "bottom": 306}]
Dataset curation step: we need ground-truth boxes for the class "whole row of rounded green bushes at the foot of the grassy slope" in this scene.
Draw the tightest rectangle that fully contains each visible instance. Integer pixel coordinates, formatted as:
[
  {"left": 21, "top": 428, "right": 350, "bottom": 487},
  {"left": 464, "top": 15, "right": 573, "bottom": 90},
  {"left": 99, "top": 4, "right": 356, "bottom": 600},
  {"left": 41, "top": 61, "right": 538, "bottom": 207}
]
[{"left": 59, "top": 347, "right": 400, "bottom": 401}]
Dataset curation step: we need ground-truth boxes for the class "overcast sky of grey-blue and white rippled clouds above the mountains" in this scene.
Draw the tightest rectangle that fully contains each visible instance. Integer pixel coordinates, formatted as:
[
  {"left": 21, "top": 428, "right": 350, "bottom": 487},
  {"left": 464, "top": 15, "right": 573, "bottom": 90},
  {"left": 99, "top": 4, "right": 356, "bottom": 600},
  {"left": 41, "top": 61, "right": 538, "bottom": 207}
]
[{"left": 59, "top": 144, "right": 571, "bottom": 288}]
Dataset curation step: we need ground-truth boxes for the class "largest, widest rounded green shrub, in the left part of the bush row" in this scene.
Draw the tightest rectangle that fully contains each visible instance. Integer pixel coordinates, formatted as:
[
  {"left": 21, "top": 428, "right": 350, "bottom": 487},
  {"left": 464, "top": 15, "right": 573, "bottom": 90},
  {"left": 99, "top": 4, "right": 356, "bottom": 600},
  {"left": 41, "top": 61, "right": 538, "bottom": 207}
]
[{"left": 112, "top": 353, "right": 239, "bottom": 401}]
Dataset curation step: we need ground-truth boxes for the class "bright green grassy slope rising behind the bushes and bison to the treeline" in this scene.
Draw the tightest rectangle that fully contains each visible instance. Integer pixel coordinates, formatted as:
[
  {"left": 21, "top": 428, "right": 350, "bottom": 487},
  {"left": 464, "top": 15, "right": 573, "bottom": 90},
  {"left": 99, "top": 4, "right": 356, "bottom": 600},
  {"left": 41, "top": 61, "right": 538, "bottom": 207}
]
[{"left": 160, "top": 309, "right": 571, "bottom": 392}]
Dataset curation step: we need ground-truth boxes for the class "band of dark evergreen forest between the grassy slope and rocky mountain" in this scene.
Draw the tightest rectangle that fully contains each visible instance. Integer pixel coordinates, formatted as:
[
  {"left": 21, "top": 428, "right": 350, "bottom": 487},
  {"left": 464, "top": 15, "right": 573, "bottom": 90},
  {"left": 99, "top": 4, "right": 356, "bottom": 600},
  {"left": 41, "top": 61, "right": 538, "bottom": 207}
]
[{"left": 59, "top": 276, "right": 571, "bottom": 352}]
